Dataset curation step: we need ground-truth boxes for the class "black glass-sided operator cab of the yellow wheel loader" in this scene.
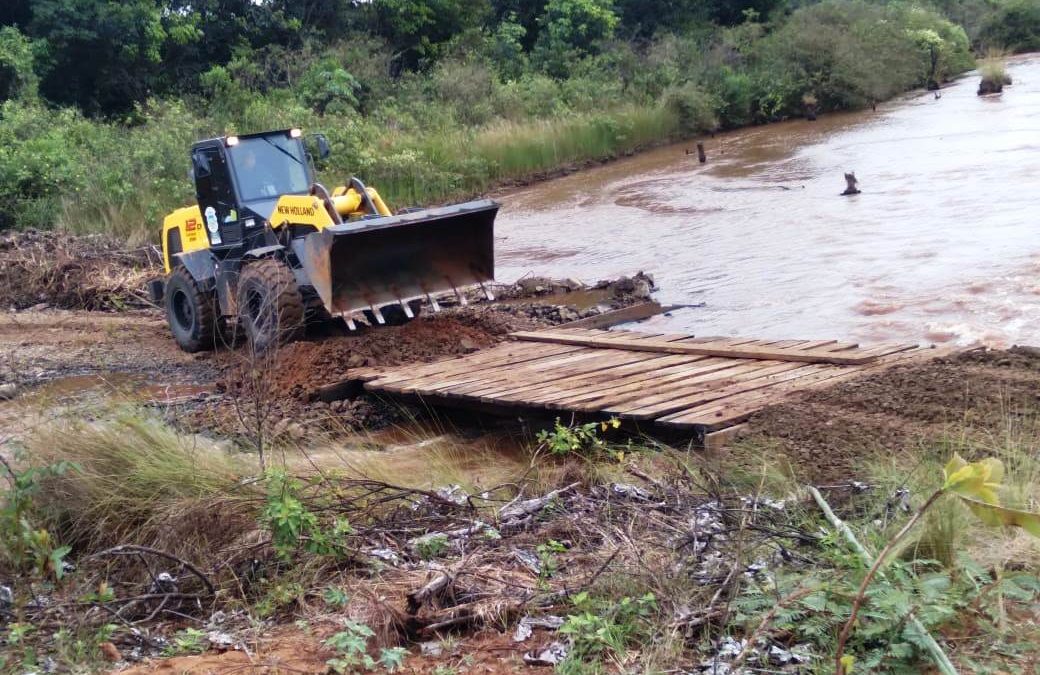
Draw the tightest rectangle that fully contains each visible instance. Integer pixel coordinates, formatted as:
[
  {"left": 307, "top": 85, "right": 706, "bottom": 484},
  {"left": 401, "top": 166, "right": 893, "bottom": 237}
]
[{"left": 191, "top": 129, "right": 318, "bottom": 250}]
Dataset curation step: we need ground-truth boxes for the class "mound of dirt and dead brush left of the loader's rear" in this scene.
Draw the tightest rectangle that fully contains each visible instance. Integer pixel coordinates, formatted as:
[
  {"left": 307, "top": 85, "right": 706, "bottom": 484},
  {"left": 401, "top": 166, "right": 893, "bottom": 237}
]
[{"left": 0, "top": 230, "right": 161, "bottom": 311}]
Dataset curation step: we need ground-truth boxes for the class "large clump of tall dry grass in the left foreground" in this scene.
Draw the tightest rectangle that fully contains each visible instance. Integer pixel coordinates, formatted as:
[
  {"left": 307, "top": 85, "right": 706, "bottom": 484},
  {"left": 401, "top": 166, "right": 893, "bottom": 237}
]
[{"left": 26, "top": 413, "right": 259, "bottom": 551}]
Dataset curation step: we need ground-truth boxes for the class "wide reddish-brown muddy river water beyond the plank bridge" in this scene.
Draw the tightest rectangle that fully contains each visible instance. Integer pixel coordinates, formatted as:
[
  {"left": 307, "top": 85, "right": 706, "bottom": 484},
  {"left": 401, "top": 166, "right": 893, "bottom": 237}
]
[{"left": 496, "top": 54, "right": 1040, "bottom": 345}]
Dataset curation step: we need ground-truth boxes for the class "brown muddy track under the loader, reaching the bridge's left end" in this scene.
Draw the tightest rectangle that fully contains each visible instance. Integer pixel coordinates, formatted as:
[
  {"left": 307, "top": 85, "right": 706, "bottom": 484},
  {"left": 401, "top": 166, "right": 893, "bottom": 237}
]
[{"left": 0, "top": 266, "right": 652, "bottom": 441}]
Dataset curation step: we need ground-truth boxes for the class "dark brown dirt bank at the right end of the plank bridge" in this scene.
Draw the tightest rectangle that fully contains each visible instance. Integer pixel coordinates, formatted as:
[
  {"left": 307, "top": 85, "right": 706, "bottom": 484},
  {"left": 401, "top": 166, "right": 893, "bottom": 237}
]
[{"left": 734, "top": 347, "right": 1040, "bottom": 483}]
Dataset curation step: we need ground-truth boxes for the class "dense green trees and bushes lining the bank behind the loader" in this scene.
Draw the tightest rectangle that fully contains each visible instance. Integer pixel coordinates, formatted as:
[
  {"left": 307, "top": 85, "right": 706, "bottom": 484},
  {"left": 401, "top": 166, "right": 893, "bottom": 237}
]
[{"left": 0, "top": 0, "right": 1027, "bottom": 234}]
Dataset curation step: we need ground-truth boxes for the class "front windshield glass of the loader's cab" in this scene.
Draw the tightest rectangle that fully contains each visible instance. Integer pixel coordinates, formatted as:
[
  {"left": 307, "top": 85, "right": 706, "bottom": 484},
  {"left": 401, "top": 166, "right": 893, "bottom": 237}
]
[{"left": 228, "top": 134, "right": 310, "bottom": 202}]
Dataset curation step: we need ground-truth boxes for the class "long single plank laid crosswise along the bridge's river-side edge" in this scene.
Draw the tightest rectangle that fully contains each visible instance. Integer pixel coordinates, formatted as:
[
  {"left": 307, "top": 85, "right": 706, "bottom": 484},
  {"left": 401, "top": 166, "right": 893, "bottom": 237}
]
[{"left": 512, "top": 332, "right": 876, "bottom": 365}]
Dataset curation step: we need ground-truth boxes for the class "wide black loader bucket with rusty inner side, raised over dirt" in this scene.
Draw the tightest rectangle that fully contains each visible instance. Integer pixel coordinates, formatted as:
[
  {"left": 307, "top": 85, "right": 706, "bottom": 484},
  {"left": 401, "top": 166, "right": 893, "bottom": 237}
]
[{"left": 296, "top": 200, "right": 498, "bottom": 315}]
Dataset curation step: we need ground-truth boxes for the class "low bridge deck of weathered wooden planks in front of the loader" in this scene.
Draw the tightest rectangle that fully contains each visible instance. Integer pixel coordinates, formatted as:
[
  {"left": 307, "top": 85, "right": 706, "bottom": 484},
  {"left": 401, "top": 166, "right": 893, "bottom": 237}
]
[{"left": 352, "top": 328, "right": 945, "bottom": 434}]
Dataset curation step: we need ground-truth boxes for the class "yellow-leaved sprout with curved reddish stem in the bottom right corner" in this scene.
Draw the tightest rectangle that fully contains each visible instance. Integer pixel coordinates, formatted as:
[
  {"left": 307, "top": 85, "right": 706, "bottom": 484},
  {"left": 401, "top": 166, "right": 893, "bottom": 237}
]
[{"left": 834, "top": 453, "right": 1040, "bottom": 675}]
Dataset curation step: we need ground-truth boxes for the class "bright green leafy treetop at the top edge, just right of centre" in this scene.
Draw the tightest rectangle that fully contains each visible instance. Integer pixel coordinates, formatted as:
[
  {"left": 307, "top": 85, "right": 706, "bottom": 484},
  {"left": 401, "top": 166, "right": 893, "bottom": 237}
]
[{"left": 535, "top": 0, "right": 618, "bottom": 77}]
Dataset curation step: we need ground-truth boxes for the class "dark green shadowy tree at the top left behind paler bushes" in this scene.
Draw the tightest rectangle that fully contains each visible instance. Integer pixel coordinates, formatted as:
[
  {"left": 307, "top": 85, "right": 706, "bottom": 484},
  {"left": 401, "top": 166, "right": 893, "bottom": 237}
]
[{"left": 29, "top": 0, "right": 166, "bottom": 114}]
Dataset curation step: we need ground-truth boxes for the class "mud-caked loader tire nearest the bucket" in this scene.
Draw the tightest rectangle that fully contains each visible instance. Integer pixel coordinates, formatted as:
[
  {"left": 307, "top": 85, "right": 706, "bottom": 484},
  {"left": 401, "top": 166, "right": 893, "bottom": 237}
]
[{"left": 237, "top": 258, "right": 305, "bottom": 353}]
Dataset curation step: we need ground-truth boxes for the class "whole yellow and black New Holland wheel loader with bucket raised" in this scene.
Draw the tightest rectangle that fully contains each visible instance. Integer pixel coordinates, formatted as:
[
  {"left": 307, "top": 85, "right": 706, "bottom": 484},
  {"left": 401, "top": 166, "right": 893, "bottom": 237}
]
[{"left": 151, "top": 129, "right": 498, "bottom": 352}]
